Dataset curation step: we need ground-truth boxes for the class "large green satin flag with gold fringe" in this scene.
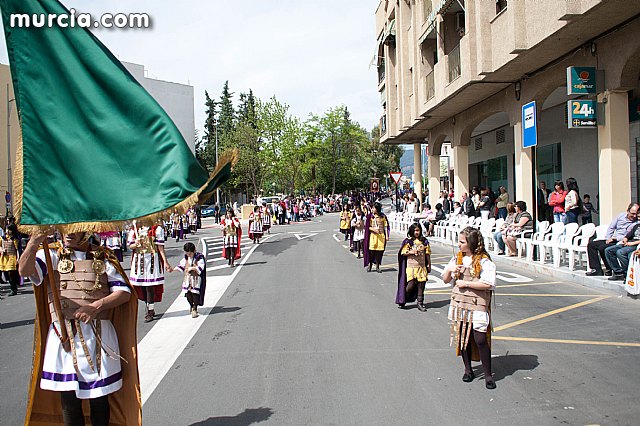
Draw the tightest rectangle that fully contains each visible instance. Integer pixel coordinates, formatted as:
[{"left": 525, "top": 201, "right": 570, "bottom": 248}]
[{"left": 0, "top": 0, "right": 236, "bottom": 232}]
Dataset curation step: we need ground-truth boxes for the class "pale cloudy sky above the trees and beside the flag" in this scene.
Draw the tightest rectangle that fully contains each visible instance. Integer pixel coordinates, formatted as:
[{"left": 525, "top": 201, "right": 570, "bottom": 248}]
[{"left": 0, "top": 0, "right": 382, "bottom": 134}]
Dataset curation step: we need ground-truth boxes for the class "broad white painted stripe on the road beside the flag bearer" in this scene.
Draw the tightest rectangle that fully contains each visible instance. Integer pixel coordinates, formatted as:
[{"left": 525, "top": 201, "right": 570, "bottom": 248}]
[{"left": 138, "top": 234, "right": 277, "bottom": 405}]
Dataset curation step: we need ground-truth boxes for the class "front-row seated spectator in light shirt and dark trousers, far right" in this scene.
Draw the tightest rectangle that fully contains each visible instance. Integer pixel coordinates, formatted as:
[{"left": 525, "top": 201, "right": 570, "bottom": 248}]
[{"left": 587, "top": 203, "right": 638, "bottom": 276}]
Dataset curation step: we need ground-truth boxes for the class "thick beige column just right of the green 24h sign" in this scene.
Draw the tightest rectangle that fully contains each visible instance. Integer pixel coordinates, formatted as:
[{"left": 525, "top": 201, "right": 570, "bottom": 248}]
[{"left": 598, "top": 92, "right": 631, "bottom": 224}]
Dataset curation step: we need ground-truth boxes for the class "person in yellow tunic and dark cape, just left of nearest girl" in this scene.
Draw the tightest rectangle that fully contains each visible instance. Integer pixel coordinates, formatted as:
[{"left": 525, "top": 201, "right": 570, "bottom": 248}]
[{"left": 396, "top": 223, "right": 431, "bottom": 312}]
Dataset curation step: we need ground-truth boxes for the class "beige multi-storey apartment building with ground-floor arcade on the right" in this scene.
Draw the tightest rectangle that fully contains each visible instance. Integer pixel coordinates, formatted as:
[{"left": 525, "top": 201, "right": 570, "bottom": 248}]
[{"left": 376, "top": 0, "right": 640, "bottom": 223}]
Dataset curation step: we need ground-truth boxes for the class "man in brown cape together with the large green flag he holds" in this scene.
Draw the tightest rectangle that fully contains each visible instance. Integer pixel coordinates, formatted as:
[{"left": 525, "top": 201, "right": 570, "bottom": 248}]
[{"left": 0, "top": 0, "right": 237, "bottom": 425}]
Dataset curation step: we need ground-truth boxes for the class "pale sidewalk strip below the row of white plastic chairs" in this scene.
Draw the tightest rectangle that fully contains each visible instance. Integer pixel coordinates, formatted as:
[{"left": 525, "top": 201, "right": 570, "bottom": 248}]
[{"left": 392, "top": 231, "right": 638, "bottom": 299}]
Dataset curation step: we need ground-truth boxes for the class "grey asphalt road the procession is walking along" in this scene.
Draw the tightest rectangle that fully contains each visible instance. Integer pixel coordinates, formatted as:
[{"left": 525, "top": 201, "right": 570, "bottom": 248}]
[{"left": 0, "top": 214, "right": 640, "bottom": 425}]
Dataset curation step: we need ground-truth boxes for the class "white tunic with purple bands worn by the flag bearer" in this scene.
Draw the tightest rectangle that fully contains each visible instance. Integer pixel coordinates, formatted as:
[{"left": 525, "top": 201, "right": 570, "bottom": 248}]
[{"left": 30, "top": 250, "right": 130, "bottom": 399}]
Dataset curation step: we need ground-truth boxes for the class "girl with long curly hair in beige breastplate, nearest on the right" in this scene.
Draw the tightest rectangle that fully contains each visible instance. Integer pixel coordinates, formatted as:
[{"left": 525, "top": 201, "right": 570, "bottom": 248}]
[{"left": 442, "top": 227, "right": 496, "bottom": 389}]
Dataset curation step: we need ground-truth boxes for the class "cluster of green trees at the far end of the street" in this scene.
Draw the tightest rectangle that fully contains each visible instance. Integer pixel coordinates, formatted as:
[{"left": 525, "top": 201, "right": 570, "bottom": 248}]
[{"left": 196, "top": 82, "right": 403, "bottom": 197}]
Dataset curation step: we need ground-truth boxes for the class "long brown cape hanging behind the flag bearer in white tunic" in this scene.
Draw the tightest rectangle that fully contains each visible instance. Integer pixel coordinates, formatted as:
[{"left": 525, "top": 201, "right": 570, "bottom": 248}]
[{"left": 24, "top": 245, "right": 142, "bottom": 426}]
